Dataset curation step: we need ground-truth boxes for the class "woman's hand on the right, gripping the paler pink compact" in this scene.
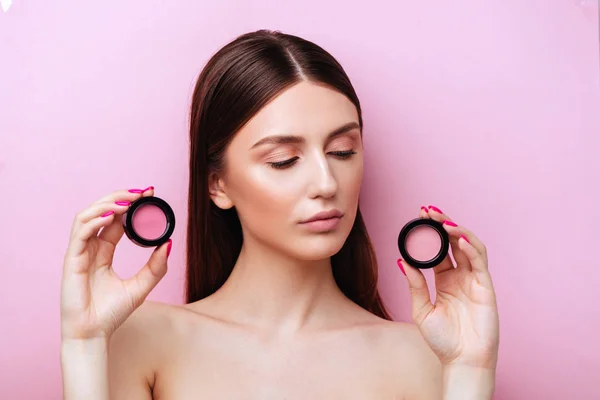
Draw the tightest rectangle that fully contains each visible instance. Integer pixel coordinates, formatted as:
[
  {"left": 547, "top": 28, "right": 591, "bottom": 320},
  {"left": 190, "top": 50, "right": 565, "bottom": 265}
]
[{"left": 398, "top": 206, "right": 499, "bottom": 369}]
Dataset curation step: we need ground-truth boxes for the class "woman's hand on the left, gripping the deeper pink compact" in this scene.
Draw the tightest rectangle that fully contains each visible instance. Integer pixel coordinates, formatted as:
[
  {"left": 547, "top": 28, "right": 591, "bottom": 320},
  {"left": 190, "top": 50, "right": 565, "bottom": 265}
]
[{"left": 61, "top": 187, "right": 171, "bottom": 341}]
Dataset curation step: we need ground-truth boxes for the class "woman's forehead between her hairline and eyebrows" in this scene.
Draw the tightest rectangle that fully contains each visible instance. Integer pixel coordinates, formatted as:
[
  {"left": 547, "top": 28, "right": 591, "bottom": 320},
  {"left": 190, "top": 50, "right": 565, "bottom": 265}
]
[{"left": 231, "top": 81, "right": 358, "bottom": 149}]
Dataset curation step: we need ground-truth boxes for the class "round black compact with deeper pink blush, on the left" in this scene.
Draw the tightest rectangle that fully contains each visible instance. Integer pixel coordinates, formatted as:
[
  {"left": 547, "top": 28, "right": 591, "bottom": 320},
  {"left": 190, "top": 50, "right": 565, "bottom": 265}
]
[{"left": 123, "top": 196, "right": 175, "bottom": 247}]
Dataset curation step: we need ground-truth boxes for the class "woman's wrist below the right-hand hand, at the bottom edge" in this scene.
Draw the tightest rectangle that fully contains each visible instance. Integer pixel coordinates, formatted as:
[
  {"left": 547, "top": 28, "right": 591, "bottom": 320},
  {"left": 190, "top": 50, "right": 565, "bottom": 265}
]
[{"left": 442, "top": 365, "right": 496, "bottom": 400}]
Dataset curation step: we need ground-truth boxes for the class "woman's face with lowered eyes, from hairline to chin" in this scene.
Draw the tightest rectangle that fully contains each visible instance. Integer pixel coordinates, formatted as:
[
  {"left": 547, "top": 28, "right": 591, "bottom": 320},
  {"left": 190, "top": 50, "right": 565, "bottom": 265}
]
[{"left": 213, "top": 82, "right": 363, "bottom": 260}]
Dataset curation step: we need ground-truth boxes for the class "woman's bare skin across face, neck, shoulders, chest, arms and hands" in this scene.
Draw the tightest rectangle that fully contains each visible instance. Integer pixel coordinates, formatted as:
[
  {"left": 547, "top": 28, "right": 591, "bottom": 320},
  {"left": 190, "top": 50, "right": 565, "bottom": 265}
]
[{"left": 61, "top": 82, "right": 498, "bottom": 400}]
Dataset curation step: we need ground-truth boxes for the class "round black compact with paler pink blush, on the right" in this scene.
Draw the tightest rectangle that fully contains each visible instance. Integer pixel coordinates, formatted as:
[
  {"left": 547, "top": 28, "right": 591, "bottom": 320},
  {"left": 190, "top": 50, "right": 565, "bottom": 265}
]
[{"left": 398, "top": 218, "right": 450, "bottom": 269}]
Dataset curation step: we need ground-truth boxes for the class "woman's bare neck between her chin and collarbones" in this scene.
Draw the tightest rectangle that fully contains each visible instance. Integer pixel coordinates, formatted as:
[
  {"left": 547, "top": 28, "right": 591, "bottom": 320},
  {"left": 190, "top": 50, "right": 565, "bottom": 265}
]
[{"left": 214, "top": 236, "right": 345, "bottom": 333}]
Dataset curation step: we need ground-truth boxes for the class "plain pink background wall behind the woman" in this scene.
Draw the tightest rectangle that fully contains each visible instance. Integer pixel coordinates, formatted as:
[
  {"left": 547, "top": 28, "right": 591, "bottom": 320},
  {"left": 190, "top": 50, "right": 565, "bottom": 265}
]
[{"left": 0, "top": 0, "right": 600, "bottom": 399}]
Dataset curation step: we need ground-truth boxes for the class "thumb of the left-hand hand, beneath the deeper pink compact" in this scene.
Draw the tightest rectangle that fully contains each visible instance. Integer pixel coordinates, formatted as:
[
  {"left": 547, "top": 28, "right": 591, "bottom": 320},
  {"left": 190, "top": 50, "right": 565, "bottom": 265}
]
[{"left": 125, "top": 239, "right": 173, "bottom": 304}]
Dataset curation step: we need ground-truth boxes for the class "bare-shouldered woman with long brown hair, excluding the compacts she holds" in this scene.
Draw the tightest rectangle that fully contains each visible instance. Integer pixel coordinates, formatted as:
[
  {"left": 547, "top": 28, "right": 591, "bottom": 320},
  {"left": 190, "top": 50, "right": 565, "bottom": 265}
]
[{"left": 61, "top": 31, "right": 498, "bottom": 400}]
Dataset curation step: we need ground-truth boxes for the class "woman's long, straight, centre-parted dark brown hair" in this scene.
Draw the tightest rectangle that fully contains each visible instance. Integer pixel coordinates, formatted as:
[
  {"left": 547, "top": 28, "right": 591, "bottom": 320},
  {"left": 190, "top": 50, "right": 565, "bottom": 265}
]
[{"left": 186, "top": 30, "right": 391, "bottom": 319}]
